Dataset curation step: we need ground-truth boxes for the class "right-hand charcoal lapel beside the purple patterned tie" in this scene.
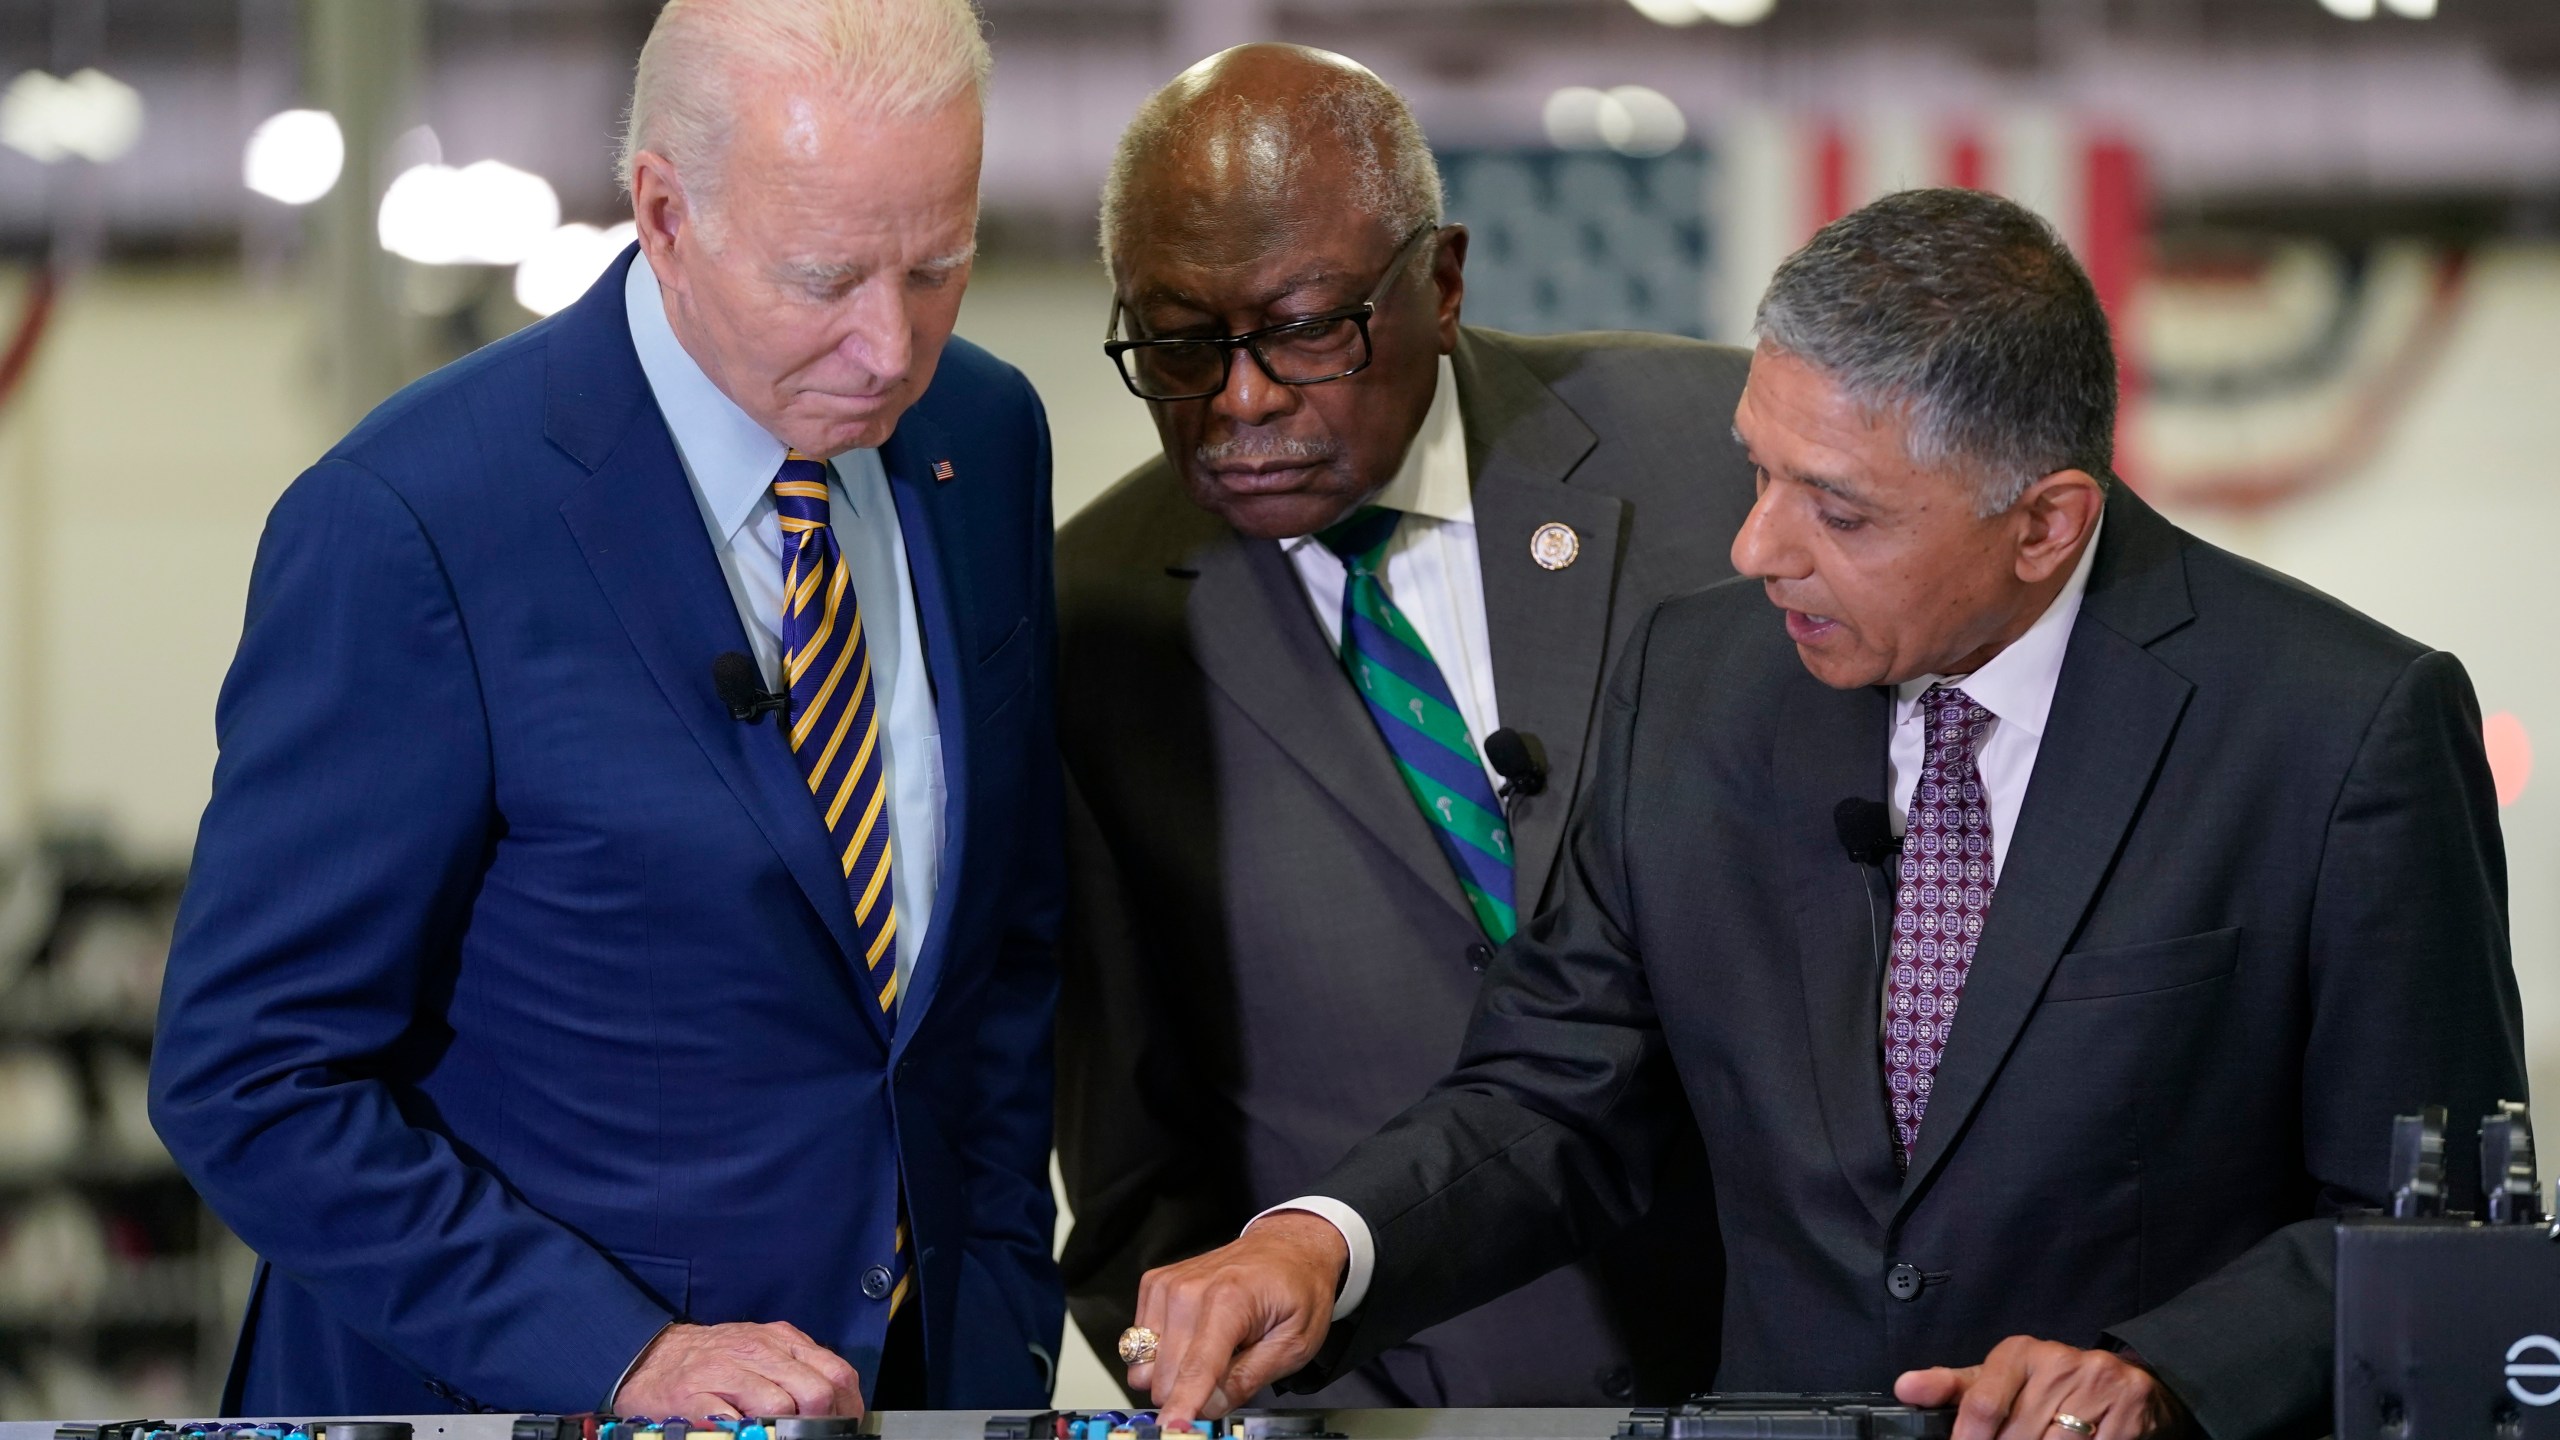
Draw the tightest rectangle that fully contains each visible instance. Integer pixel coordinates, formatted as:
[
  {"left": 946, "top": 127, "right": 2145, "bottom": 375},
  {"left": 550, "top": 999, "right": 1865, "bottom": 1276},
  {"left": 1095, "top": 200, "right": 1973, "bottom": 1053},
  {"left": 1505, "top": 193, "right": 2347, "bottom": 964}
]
[{"left": 1900, "top": 482, "right": 2194, "bottom": 1209}]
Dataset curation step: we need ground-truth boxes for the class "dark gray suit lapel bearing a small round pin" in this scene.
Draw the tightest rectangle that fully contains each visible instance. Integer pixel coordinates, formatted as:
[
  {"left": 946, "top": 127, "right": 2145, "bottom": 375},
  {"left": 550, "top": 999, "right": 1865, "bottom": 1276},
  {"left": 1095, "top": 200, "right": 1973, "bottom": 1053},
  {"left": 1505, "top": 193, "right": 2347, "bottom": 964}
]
[{"left": 1457, "top": 333, "right": 1626, "bottom": 901}]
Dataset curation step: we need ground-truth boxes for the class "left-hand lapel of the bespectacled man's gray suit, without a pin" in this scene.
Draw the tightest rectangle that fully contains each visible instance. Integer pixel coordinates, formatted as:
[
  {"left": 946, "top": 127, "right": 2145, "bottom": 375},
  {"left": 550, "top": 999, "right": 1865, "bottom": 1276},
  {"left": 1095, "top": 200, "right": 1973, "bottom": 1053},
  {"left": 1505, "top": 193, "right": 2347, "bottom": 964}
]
[{"left": 1188, "top": 533, "right": 1475, "bottom": 925}]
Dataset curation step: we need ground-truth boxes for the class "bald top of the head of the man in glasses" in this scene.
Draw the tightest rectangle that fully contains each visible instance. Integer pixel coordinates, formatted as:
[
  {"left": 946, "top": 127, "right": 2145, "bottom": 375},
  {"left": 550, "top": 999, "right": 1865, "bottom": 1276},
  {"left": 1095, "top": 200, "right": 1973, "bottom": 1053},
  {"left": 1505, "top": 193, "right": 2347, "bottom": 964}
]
[{"left": 1101, "top": 44, "right": 1441, "bottom": 274}]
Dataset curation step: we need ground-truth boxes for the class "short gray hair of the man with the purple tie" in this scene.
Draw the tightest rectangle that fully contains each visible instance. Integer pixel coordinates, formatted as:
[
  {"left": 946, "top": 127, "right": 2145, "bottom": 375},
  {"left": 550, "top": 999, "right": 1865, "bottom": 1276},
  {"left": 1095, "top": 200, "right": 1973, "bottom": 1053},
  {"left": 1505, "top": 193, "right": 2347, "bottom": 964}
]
[{"left": 1754, "top": 190, "right": 2115, "bottom": 515}]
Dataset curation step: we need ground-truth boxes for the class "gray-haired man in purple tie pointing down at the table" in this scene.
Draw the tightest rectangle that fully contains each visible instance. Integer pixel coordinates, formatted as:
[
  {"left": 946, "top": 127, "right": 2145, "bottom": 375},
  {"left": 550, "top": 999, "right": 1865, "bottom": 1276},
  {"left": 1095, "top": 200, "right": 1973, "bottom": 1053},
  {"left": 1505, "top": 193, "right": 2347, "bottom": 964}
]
[{"left": 1132, "top": 190, "right": 2524, "bottom": 1440}]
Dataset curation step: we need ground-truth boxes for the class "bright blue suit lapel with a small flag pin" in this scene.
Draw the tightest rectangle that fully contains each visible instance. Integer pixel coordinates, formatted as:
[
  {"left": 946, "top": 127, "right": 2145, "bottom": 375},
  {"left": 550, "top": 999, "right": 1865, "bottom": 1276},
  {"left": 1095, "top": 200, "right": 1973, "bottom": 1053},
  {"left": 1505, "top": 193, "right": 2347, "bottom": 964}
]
[{"left": 881, "top": 415, "right": 978, "bottom": 1040}]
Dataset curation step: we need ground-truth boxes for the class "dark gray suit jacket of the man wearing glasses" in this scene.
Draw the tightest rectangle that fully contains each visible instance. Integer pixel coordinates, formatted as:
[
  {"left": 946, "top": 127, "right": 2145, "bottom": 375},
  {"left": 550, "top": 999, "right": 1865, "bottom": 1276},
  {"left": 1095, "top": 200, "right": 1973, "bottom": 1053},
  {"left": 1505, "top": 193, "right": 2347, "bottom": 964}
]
[{"left": 1057, "top": 331, "right": 1751, "bottom": 1407}]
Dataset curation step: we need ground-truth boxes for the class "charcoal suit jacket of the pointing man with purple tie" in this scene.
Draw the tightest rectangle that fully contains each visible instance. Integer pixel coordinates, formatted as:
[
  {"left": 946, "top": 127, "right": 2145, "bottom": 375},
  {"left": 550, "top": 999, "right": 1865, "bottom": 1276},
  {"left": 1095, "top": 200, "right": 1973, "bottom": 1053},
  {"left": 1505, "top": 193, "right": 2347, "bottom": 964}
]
[{"left": 1293, "top": 487, "right": 2524, "bottom": 1440}]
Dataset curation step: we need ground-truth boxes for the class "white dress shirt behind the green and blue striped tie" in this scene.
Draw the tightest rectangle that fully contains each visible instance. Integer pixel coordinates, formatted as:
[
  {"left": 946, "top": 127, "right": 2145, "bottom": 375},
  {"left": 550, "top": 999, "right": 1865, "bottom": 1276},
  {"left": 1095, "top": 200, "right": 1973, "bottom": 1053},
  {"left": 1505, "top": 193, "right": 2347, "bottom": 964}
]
[{"left": 1280, "top": 356, "right": 1503, "bottom": 792}]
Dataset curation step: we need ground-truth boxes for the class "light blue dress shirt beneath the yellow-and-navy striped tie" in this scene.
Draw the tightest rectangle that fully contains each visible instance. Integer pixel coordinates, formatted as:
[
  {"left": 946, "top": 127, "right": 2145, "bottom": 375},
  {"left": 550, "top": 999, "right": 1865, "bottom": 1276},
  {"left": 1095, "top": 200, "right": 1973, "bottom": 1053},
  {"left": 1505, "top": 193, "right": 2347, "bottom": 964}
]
[{"left": 622, "top": 254, "right": 945, "bottom": 997}]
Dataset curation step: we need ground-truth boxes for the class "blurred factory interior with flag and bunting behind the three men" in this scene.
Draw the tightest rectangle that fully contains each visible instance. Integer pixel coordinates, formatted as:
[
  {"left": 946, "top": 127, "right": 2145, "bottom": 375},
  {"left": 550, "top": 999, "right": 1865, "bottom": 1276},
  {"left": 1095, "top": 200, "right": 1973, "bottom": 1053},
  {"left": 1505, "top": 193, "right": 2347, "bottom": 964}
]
[{"left": 0, "top": 0, "right": 2560, "bottom": 1417}]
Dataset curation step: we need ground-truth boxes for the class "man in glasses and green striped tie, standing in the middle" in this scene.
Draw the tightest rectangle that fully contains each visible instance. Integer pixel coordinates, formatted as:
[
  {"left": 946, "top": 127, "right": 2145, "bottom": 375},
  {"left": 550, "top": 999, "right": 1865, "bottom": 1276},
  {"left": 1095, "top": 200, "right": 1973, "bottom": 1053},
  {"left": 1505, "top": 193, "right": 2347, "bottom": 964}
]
[{"left": 1060, "top": 46, "right": 1751, "bottom": 1407}]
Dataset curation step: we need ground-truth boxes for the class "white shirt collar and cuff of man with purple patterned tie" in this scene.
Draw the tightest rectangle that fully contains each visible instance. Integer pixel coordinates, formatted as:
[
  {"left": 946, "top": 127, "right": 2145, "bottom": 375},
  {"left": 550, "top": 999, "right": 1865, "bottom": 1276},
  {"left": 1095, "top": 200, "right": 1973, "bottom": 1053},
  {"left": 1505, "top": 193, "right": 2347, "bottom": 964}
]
[{"left": 1269, "top": 520, "right": 2107, "bottom": 1320}]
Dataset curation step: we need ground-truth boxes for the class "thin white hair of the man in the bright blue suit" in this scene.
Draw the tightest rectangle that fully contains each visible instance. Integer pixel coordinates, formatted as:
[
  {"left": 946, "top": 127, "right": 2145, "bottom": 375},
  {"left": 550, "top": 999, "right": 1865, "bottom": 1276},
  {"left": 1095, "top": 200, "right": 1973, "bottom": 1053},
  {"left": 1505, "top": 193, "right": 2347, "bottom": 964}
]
[{"left": 617, "top": 0, "right": 993, "bottom": 202}]
